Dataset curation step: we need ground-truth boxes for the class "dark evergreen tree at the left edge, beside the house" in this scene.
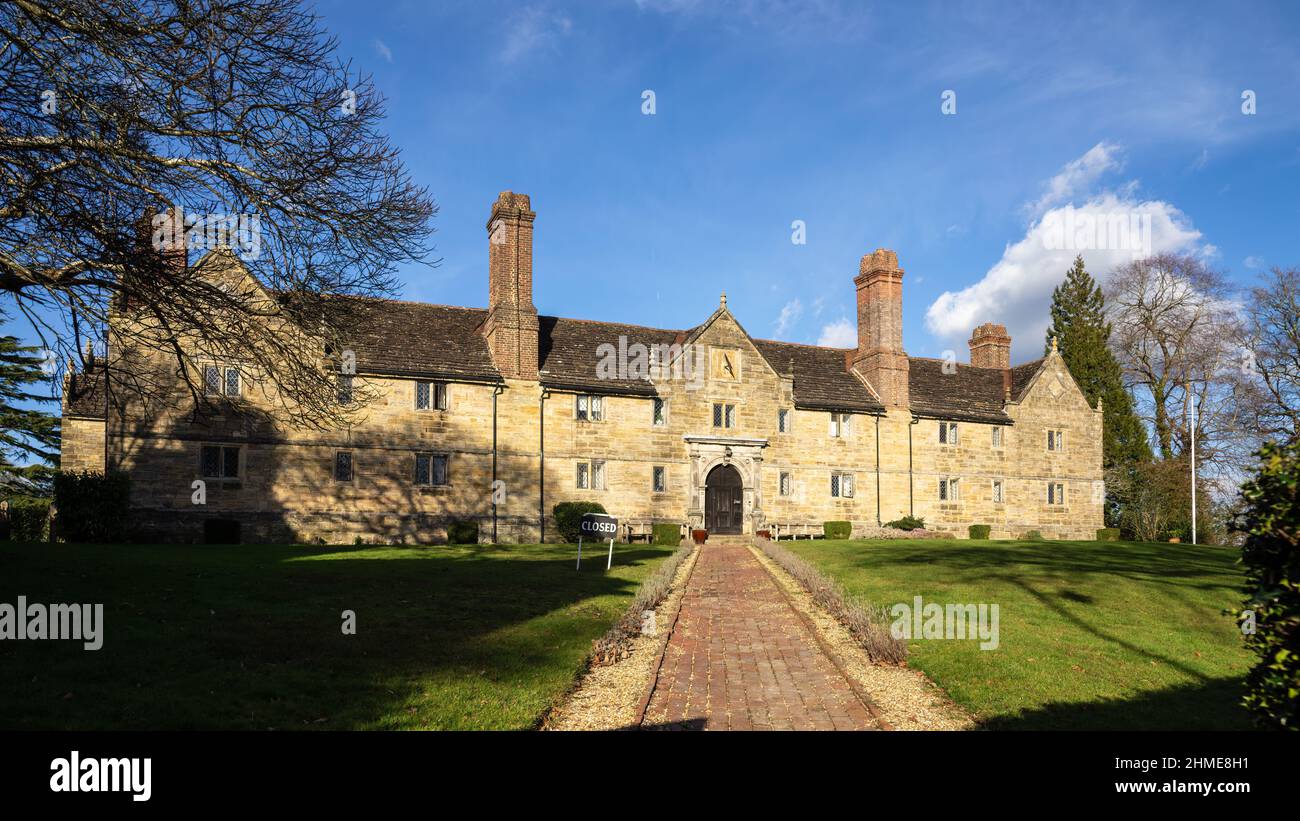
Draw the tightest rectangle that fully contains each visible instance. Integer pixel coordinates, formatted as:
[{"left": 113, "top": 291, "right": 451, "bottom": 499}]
[{"left": 0, "top": 323, "right": 60, "bottom": 487}]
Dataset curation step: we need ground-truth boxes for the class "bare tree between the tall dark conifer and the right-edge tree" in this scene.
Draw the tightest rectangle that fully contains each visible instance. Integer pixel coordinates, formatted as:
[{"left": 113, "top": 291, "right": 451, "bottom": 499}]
[{"left": 1106, "top": 255, "right": 1245, "bottom": 475}]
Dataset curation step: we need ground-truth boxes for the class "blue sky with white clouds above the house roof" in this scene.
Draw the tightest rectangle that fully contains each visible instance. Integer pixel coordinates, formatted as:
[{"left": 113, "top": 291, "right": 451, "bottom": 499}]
[{"left": 306, "top": 0, "right": 1300, "bottom": 360}]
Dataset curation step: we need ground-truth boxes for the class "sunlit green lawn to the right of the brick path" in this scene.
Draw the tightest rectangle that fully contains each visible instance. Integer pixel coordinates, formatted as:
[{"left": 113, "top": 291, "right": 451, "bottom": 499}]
[{"left": 785, "top": 540, "right": 1251, "bottom": 730}]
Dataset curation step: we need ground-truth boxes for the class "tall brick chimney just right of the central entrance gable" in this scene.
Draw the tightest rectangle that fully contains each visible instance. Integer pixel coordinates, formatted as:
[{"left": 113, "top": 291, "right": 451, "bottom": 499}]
[{"left": 853, "top": 248, "right": 909, "bottom": 408}]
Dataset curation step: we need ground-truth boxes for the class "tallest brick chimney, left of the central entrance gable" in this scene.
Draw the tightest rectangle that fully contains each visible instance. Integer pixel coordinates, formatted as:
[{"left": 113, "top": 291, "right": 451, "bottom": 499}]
[{"left": 482, "top": 191, "right": 537, "bottom": 379}]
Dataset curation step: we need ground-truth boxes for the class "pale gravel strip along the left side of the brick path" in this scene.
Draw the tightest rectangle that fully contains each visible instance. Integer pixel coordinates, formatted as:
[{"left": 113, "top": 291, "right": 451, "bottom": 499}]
[{"left": 541, "top": 548, "right": 699, "bottom": 730}]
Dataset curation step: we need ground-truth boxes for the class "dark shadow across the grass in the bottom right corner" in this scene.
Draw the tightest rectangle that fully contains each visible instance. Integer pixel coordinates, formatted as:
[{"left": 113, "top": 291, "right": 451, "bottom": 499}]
[{"left": 980, "top": 677, "right": 1252, "bottom": 730}]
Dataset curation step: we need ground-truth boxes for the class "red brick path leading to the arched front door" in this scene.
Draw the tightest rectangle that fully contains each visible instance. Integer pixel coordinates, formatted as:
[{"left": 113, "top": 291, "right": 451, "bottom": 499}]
[{"left": 642, "top": 544, "right": 876, "bottom": 730}]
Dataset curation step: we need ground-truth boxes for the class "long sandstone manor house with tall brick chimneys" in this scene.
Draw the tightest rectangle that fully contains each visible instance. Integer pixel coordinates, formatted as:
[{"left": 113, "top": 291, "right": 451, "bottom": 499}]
[{"left": 61, "top": 192, "right": 1104, "bottom": 543}]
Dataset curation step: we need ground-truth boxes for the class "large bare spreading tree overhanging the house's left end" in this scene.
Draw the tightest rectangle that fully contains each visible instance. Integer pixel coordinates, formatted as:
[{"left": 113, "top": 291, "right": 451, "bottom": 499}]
[{"left": 0, "top": 0, "right": 437, "bottom": 426}]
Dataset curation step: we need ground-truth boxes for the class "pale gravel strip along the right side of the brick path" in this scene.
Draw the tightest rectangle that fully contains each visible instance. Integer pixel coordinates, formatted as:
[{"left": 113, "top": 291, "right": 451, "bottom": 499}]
[{"left": 750, "top": 546, "right": 976, "bottom": 730}]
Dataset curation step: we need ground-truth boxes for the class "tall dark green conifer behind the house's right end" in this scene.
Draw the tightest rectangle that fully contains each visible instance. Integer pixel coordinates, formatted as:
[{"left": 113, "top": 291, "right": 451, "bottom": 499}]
[{"left": 1045, "top": 256, "right": 1152, "bottom": 521}]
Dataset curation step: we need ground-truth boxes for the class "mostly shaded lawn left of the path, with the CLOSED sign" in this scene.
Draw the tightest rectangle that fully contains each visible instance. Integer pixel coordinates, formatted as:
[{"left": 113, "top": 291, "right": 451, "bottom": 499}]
[{"left": 0, "top": 543, "right": 671, "bottom": 730}]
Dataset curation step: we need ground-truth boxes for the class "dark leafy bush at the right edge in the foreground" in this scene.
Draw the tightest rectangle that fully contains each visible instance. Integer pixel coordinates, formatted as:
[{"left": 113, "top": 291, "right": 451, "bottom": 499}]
[{"left": 1238, "top": 442, "right": 1300, "bottom": 730}]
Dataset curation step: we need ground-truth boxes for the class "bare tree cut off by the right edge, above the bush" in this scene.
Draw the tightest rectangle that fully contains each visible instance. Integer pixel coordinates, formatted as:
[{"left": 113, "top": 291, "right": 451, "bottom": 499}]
[{"left": 1240, "top": 268, "right": 1300, "bottom": 442}]
